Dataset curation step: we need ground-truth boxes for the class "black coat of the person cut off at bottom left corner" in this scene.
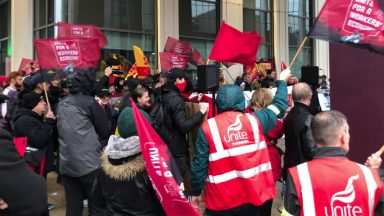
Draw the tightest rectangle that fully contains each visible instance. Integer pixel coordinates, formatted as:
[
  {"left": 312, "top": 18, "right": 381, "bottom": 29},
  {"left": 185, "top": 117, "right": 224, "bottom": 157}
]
[{"left": 0, "top": 129, "right": 48, "bottom": 216}]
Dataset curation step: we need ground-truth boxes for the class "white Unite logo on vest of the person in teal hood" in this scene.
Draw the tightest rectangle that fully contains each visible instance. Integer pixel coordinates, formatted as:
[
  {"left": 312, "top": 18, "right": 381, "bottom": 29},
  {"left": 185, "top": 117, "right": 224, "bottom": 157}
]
[{"left": 223, "top": 114, "right": 249, "bottom": 145}]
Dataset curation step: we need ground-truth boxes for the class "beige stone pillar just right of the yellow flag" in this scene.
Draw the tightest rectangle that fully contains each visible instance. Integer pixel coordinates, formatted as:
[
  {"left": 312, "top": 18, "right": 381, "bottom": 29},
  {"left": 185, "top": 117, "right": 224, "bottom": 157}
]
[{"left": 156, "top": 0, "right": 179, "bottom": 68}]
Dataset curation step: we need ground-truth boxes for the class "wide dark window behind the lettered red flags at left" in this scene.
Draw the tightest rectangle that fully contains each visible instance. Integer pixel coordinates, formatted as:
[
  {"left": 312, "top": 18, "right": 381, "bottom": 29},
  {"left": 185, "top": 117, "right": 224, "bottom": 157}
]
[{"left": 34, "top": 0, "right": 157, "bottom": 68}]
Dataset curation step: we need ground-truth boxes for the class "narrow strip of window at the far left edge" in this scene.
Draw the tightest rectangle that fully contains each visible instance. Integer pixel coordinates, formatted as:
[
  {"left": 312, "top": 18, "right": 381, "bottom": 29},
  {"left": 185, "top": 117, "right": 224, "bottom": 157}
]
[{"left": 0, "top": 0, "right": 11, "bottom": 75}]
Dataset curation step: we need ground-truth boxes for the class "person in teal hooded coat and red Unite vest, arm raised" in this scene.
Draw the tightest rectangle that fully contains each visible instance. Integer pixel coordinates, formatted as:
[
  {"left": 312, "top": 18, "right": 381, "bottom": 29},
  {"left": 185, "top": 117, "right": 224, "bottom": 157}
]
[{"left": 191, "top": 69, "right": 291, "bottom": 216}]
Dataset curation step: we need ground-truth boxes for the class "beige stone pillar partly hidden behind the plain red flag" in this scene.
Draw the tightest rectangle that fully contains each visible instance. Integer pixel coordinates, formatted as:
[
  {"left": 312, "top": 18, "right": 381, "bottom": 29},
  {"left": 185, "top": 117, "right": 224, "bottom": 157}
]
[{"left": 220, "top": 0, "right": 243, "bottom": 83}]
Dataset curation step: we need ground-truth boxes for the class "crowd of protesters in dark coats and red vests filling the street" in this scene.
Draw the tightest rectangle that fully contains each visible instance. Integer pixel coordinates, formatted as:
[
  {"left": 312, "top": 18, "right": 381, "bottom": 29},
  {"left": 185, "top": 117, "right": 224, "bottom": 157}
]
[{"left": 0, "top": 62, "right": 383, "bottom": 216}]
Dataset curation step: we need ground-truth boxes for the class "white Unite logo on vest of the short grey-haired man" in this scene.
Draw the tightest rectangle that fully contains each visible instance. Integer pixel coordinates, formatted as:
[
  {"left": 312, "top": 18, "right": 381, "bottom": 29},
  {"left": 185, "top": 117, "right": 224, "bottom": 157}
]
[{"left": 324, "top": 175, "right": 363, "bottom": 216}]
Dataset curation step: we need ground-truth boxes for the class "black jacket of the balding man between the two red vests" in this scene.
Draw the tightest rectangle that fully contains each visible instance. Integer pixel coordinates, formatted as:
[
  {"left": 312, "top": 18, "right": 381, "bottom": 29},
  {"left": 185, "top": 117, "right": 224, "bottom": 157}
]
[{"left": 283, "top": 102, "right": 315, "bottom": 179}]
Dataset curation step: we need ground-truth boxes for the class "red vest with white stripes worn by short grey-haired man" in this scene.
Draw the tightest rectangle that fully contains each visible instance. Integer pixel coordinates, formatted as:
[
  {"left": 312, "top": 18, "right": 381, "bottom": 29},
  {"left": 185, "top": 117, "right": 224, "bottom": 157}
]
[{"left": 288, "top": 157, "right": 382, "bottom": 216}]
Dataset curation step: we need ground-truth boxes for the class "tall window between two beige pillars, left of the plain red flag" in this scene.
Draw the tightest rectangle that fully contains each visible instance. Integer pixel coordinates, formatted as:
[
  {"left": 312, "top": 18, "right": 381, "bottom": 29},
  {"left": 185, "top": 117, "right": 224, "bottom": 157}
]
[{"left": 179, "top": 0, "right": 220, "bottom": 59}]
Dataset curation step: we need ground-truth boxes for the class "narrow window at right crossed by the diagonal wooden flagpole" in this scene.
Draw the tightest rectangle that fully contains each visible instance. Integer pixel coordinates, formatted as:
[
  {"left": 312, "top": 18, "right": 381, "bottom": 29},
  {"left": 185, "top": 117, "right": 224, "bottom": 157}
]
[{"left": 288, "top": 0, "right": 313, "bottom": 78}]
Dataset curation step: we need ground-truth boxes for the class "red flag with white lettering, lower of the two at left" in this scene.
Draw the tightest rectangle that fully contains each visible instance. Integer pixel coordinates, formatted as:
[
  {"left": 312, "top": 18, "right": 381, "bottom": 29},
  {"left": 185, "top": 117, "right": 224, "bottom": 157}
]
[{"left": 35, "top": 39, "right": 100, "bottom": 70}]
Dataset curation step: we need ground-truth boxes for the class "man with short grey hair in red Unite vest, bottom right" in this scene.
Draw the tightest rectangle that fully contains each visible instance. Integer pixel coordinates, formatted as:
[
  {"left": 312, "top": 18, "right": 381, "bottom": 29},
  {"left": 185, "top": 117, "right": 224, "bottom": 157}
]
[{"left": 282, "top": 111, "right": 383, "bottom": 216}]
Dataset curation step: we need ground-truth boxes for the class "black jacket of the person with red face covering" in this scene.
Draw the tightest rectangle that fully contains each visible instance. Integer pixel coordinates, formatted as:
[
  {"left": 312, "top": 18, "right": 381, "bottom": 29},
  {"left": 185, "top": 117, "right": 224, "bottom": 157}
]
[{"left": 161, "top": 84, "right": 204, "bottom": 157}]
